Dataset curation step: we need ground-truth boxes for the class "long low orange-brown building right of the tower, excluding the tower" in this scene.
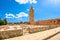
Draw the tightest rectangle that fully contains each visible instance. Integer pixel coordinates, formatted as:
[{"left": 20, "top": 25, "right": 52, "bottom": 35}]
[{"left": 35, "top": 19, "right": 60, "bottom": 25}]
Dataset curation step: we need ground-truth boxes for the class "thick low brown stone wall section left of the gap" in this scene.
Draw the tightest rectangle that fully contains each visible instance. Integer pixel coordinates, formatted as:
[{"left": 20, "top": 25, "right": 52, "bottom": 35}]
[{"left": 0, "top": 30, "right": 23, "bottom": 38}]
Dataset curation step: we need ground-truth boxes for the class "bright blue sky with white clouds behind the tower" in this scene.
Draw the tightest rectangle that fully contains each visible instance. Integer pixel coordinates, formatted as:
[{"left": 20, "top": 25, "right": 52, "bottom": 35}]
[{"left": 0, "top": 0, "right": 60, "bottom": 22}]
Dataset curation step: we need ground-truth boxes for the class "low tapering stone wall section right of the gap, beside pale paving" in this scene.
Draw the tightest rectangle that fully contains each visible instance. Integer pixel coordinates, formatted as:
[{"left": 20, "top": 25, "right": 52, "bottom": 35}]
[{"left": 28, "top": 26, "right": 59, "bottom": 33}]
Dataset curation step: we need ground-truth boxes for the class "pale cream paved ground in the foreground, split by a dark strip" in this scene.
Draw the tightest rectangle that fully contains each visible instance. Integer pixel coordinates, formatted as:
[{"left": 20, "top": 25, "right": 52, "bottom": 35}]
[{"left": 5, "top": 27, "right": 60, "bottom": 40}]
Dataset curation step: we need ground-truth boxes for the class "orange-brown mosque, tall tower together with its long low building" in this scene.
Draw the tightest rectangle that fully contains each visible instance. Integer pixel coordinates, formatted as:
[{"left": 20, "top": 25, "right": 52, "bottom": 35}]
[{"left": 29, "top": 7, "right": 60, "bottom": 25}]
